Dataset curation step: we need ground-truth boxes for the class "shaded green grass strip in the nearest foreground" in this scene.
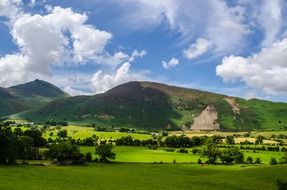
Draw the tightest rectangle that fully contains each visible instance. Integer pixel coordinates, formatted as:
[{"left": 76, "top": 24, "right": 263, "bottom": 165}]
[{"left": 0, "top": 164, "right": 287, "bottom": 190}]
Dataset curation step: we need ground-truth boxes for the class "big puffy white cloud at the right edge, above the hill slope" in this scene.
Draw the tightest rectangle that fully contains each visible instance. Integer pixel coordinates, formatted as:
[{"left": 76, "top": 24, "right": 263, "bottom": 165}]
[{"left": 216, "top": 38, "right": 287, "bottom": 95}]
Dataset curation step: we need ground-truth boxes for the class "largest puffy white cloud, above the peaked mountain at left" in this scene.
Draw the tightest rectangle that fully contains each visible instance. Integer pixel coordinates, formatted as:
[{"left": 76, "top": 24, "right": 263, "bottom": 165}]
[{"left": 0, "top": 5, "right": 112, "bottom": 86}]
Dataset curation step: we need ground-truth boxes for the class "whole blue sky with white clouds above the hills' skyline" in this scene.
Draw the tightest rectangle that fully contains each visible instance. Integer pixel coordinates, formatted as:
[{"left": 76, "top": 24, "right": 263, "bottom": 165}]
[{"left": 0, "top": 0, "right": 287, "bottom": 101}]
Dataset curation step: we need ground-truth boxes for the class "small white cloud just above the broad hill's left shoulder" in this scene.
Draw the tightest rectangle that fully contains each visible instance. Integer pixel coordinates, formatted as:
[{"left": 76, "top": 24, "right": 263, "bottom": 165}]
[{"left": 91, "top": 62, "right": 147, "bottom": 94}]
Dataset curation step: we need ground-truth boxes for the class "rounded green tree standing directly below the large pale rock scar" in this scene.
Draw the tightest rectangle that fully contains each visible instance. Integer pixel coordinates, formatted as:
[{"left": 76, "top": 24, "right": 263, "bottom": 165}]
[{"left": 201, "top": 141, "right": 220, "bottom": 164}]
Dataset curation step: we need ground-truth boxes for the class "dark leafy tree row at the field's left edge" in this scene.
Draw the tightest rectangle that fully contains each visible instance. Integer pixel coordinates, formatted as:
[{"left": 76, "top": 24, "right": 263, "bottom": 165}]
[{"left": 0, "top": 126, "right": 115, "bottom": 164}]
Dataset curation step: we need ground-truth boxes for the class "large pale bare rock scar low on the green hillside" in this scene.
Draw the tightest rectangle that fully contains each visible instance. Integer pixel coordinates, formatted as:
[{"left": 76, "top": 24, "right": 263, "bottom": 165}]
[{"left": 194, "top": 105, "right": 220, "bottom": 130}]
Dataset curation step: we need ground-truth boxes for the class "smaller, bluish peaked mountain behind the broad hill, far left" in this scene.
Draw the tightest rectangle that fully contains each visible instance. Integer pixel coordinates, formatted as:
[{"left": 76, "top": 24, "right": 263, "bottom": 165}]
[{"left": 0, "top": 79, "right": 69, "bottom": 117}]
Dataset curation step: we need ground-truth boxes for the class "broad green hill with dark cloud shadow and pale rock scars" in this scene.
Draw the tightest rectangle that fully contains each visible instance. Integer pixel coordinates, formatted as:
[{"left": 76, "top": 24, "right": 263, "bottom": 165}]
[{"left": 21, "top": 82, "right": 287, "bottom": 131}]
